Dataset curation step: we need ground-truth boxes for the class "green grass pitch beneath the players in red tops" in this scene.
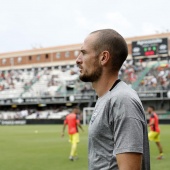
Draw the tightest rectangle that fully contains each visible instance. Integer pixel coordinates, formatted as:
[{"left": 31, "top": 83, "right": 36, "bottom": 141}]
[{"left": 0, "top": 125, "right": 170, "bottom": 170}]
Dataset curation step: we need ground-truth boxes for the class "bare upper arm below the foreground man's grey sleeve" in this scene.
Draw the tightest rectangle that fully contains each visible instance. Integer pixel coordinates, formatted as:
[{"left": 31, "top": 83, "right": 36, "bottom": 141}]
[{"left": 116, "top": 152, "right": 142, "bottom": 170}]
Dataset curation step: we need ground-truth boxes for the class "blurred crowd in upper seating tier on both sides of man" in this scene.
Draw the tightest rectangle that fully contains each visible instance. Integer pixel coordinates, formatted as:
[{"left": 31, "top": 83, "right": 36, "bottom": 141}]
[{"left": 0, "top": 60, "right": 170, "bottom": 99}]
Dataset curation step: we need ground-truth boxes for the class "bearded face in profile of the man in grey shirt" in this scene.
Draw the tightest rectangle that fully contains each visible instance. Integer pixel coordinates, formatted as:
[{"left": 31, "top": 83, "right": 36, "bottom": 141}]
[{"left": 76, "top": 34, "right": 102, "bottom": 82}]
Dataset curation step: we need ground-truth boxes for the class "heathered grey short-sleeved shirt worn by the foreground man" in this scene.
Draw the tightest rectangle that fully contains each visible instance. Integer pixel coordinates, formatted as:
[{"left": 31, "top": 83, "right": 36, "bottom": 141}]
[{"left": 88, "top": 81, "right": 150, "bottom": 170}]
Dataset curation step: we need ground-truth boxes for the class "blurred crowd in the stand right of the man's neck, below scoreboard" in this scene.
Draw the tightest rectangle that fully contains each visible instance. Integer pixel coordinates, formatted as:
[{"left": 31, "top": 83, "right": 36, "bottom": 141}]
[{"left": 119, "top": 60, "right": 170, "bottom": 91}]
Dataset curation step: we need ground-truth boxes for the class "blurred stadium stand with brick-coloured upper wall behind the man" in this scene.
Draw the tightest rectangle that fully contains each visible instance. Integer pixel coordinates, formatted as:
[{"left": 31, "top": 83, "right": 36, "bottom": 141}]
[{"left": 0, "top": 33, "right": 170, "bottom": 122}]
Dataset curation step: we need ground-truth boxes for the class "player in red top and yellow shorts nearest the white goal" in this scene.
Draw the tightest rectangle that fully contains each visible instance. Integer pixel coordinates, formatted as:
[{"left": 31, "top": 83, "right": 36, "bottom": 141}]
[{"left": 62, "top": 108, "right": 84, "bottom": 161}]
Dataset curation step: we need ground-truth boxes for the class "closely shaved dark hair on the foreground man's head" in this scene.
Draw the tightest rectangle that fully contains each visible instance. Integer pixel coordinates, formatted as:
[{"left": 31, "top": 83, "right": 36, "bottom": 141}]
[{"left": 90, "top": 29, "right": 128, "bottom": 71}]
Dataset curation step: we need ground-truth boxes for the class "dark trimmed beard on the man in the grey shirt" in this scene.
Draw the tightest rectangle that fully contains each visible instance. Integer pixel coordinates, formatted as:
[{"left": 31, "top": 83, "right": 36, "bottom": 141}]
[{"left": 79, "top": 63, "right": 102, "bottom": 82}]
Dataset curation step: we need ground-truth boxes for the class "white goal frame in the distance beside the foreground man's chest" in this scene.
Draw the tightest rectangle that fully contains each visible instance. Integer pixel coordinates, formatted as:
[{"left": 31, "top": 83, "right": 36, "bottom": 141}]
[{"left": 83, "top": 107, "right": 94, "bottom": 125}]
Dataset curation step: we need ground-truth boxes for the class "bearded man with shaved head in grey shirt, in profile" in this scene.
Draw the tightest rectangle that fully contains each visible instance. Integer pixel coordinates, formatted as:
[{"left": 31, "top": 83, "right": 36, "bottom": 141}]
[{"left": 76, "top": 29, "right": 150, "bottom": 170}]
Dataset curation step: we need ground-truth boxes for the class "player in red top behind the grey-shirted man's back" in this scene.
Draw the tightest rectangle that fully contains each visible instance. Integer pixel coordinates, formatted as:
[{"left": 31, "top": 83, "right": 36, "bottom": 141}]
[{"left": 147, "top": 106, "right": 163, "bottom": 160}]
